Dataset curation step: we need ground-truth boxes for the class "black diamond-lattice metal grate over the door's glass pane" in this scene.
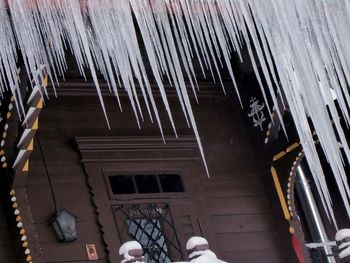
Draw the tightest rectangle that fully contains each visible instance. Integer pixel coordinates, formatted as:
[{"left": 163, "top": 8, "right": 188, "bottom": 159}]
[{"left": 115, "top": 204, "right": 183, "bottom": 263}]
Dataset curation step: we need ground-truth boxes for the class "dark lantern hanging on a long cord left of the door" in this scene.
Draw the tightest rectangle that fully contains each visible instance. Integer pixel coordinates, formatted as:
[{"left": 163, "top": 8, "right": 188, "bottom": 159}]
[{"left": 51, "top": 209, "right": 78, "bottom": 242}]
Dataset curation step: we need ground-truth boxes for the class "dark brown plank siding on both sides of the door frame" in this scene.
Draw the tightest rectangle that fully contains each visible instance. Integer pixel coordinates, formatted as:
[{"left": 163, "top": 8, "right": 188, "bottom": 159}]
[{"left": 26, "top": 85, "right": 293, "bottom": 263}]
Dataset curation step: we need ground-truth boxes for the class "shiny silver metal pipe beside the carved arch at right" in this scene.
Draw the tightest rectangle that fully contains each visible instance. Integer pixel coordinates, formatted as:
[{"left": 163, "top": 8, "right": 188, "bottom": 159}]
[{"left": 295, "top": 165, "right": 336, "bottom": 263}]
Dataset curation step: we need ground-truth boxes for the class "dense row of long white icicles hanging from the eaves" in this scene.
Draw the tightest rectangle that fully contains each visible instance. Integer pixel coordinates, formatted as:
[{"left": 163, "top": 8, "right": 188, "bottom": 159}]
[{"left": 0, "top": 0, "right": 350, "bottom": 227}]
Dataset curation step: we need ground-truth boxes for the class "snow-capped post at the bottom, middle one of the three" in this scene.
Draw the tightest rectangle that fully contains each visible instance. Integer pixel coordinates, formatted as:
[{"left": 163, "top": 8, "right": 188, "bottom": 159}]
[{"left": 186, "top": 236, "right": 225, "bottom": 263}]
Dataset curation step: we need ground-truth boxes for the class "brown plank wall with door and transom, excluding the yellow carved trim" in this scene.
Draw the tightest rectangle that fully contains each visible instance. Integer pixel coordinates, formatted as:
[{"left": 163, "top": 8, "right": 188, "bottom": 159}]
[{"left": 0, "top": 69, "right": 296, "bottom": 263}]
